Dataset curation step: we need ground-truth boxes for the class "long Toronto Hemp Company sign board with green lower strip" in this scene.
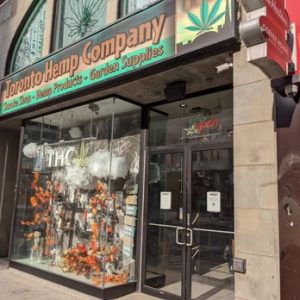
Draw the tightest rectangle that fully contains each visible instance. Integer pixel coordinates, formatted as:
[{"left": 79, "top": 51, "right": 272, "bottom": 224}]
[{"left": 0, "top": 0, "right": 235, "bottom": 116}]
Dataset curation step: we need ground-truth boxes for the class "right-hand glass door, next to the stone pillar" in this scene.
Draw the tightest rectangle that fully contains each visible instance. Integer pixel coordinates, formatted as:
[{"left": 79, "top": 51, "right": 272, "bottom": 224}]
[{"left": 187, "top": 148, "right": 234, "bottom": 300}]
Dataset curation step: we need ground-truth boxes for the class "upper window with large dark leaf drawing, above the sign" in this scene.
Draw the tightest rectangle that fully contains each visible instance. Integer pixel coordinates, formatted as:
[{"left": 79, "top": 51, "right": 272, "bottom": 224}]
[{"left": 56, "top": 0, "right": 109, "bottom": 48}]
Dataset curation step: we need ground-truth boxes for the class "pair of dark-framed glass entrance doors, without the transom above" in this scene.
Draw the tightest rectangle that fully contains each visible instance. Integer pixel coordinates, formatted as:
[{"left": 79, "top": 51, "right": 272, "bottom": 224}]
[{"left": 143, "top": 144, "right": 234, "bottom": 300}]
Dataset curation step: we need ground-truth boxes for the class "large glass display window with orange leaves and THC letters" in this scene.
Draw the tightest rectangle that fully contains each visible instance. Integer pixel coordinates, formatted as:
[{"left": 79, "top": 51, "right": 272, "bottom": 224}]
[{"left": 12, "top": 98, "right": 141, "bottom": 288}]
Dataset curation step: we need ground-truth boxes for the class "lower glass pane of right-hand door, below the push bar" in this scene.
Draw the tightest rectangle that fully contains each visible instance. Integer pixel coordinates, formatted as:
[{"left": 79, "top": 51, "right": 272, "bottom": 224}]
[{"left": 190, "top": 230, "right": 234, "bottom": 300}]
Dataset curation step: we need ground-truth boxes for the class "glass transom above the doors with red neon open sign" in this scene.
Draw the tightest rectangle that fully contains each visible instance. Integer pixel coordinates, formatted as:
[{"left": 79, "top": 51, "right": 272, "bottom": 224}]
[{"left": 149, "top": 90, "right": 233, "bottom": 146}]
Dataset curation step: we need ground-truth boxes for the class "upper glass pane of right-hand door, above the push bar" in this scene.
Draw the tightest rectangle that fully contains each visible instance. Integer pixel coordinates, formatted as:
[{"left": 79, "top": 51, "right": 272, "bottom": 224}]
[{"left": 191, "top": 149, "right": 234, "bottom": 231}]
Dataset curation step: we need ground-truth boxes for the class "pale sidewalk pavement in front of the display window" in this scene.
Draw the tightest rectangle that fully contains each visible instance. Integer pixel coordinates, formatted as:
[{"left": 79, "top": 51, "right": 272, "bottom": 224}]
[{"left": 0, "top": 260, "right": 158, "bottom": 300}]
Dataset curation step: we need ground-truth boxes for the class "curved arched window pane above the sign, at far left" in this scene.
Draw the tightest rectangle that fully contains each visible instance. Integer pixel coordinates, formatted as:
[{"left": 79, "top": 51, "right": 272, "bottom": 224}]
[{"left": 10, "top": 1, "right": 46, "bottom": 72}]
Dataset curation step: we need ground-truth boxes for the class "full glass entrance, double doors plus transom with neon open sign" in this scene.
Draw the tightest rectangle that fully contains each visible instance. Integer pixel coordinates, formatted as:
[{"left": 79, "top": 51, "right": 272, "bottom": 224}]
[{"left": 145, "top": 90, "right": 234, "bottom": 300}]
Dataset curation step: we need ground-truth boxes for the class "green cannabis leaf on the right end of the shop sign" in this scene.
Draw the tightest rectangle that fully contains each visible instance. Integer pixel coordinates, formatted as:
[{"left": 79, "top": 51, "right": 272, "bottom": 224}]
[{"left": 186, "top": 0, "right": 226, "bottom": 36}]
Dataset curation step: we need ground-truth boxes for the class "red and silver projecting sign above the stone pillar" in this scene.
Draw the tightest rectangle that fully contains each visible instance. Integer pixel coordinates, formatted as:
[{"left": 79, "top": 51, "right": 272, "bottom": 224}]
[{"left": 240, "top": 0, "right": 292, "bottom": 79}]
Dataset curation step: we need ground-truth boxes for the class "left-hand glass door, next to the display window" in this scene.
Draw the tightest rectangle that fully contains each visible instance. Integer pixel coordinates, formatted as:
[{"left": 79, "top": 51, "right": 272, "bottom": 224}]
[{"left": 144, "top": 149, "right": 187, "bottom": 299}]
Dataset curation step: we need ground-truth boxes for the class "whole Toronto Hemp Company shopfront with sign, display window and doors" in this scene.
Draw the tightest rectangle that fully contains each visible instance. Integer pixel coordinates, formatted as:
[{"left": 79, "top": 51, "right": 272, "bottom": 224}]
[{"left": 0, "top": 0, "right": 239, "bottom": 299}]
